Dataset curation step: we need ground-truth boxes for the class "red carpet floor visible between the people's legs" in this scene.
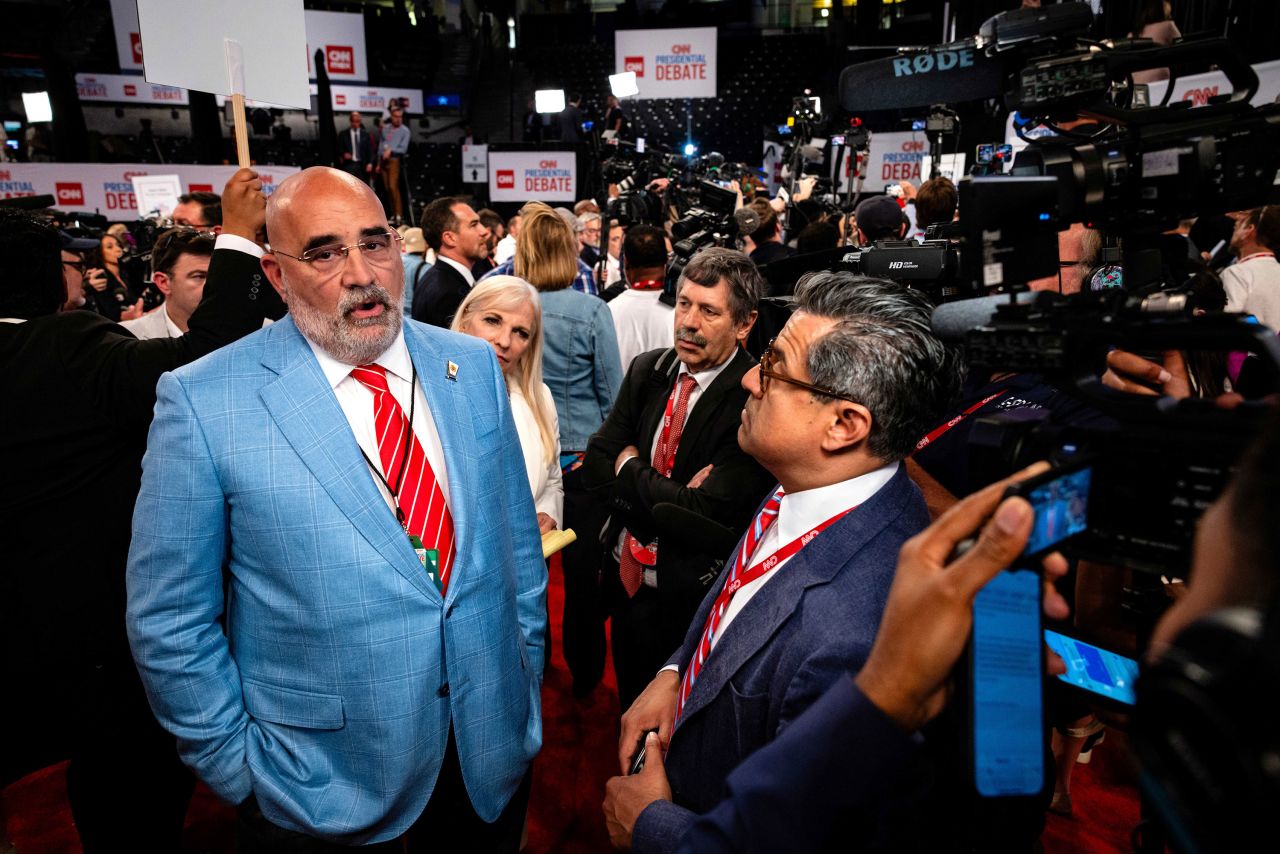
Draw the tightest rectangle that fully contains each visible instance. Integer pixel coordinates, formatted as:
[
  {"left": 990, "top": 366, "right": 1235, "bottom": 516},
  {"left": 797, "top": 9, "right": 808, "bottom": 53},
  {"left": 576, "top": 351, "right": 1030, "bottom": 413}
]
[{"left": 0, "top": 562, "right": 1138, "bottom": 854}]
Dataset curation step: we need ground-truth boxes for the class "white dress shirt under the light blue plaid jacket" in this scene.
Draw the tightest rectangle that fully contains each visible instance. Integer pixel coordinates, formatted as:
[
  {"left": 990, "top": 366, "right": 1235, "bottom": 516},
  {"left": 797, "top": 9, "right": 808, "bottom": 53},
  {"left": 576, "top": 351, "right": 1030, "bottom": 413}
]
[{"left": 307, "top": 330, "right": 453, "bottom": 513}]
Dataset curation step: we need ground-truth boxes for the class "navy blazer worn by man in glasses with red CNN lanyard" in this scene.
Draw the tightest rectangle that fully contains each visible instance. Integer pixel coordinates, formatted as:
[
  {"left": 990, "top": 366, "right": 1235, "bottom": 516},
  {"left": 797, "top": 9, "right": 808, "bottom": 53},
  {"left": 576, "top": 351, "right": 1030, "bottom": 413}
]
[{"left": 632, "top": 465, "right": 929, "bottom": 851}]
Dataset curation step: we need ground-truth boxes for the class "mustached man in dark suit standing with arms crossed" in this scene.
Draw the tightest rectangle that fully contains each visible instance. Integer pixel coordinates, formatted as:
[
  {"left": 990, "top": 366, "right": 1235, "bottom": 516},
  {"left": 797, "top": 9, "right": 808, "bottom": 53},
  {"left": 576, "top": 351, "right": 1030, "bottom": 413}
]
[{"left": 586, "top": 248, "right": 773, "bottom": 708}]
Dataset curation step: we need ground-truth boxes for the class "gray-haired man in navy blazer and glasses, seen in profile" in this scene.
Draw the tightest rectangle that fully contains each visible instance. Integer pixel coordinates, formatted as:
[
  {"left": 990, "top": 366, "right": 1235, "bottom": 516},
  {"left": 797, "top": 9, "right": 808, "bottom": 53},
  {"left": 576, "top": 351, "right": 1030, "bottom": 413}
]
[{"left": 607, "top": 273, "right": 961, "bottom": 851}]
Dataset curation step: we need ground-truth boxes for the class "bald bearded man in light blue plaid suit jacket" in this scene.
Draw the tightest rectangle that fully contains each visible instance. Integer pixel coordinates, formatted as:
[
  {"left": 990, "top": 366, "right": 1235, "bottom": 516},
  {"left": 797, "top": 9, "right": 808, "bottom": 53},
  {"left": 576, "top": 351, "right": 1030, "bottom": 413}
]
[{"left": 128, "top": 168, "right": 547, "bottom": 851}]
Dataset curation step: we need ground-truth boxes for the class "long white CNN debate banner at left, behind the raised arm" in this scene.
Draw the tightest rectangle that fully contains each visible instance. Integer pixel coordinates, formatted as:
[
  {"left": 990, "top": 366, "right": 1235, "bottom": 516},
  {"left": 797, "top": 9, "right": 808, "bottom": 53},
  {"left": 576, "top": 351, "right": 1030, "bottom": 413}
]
[{"left": 0, "top": 163, "right": 298, "bottom": 220}]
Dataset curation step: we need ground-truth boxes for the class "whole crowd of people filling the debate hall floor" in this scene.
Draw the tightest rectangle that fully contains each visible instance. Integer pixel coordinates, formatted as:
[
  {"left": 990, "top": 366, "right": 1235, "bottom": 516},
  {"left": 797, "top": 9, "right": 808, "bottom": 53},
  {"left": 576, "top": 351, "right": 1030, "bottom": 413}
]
[{"left": 0, "top": 140, "right": 1280, "bottom": 851}]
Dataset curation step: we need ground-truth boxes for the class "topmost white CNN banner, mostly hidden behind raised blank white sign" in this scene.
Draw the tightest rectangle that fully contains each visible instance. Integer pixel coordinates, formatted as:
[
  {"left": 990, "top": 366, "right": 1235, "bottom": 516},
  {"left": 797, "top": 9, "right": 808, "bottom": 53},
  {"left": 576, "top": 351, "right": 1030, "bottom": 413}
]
[{"left": 110, "top": 0, "right": 369, "bottom": 83}]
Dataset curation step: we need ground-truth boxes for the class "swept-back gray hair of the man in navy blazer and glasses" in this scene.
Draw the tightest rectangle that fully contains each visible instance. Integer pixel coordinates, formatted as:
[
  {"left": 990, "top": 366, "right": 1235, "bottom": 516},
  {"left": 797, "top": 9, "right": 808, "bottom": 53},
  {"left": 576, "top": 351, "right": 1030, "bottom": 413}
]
[{"left": 795, "top": 273, "right": 965, "bottom": 461}]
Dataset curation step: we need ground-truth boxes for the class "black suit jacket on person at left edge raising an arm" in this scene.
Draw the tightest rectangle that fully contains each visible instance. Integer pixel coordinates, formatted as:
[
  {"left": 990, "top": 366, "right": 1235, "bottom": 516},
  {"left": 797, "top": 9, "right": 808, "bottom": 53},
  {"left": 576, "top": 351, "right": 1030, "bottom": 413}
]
[{"left": 0, "top": 243, "right": 270, "bottom": 782}]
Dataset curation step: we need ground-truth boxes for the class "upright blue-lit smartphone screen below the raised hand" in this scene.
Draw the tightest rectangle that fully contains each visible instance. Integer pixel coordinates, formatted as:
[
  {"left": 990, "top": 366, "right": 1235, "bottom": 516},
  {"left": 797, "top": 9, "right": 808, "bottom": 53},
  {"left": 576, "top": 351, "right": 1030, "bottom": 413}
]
[{"left": 970, "top": 570, "right": 1044, "bottom": 798}]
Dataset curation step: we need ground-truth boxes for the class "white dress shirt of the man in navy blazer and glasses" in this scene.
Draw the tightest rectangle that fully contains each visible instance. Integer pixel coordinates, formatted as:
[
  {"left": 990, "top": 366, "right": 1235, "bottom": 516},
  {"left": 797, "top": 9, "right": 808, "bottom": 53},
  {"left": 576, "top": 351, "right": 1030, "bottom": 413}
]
[{"left": 663, "top": 462, "right": 899, "bottom": 671}]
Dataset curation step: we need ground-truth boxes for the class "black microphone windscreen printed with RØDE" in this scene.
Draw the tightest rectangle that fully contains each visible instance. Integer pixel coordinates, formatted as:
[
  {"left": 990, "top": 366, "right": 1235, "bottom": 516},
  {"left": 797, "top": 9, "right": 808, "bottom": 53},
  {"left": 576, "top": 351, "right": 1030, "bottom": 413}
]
[{"left": 840, "top": 42, "right": 1004, "bottom": 113}]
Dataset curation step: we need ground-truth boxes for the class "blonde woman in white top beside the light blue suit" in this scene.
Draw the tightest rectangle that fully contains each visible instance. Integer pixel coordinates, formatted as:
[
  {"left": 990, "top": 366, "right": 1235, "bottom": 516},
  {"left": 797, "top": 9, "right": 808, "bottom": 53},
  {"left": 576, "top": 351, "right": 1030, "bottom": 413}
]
[{"left": 453, "top": 275, "right": 564, "bottom": 534}]
